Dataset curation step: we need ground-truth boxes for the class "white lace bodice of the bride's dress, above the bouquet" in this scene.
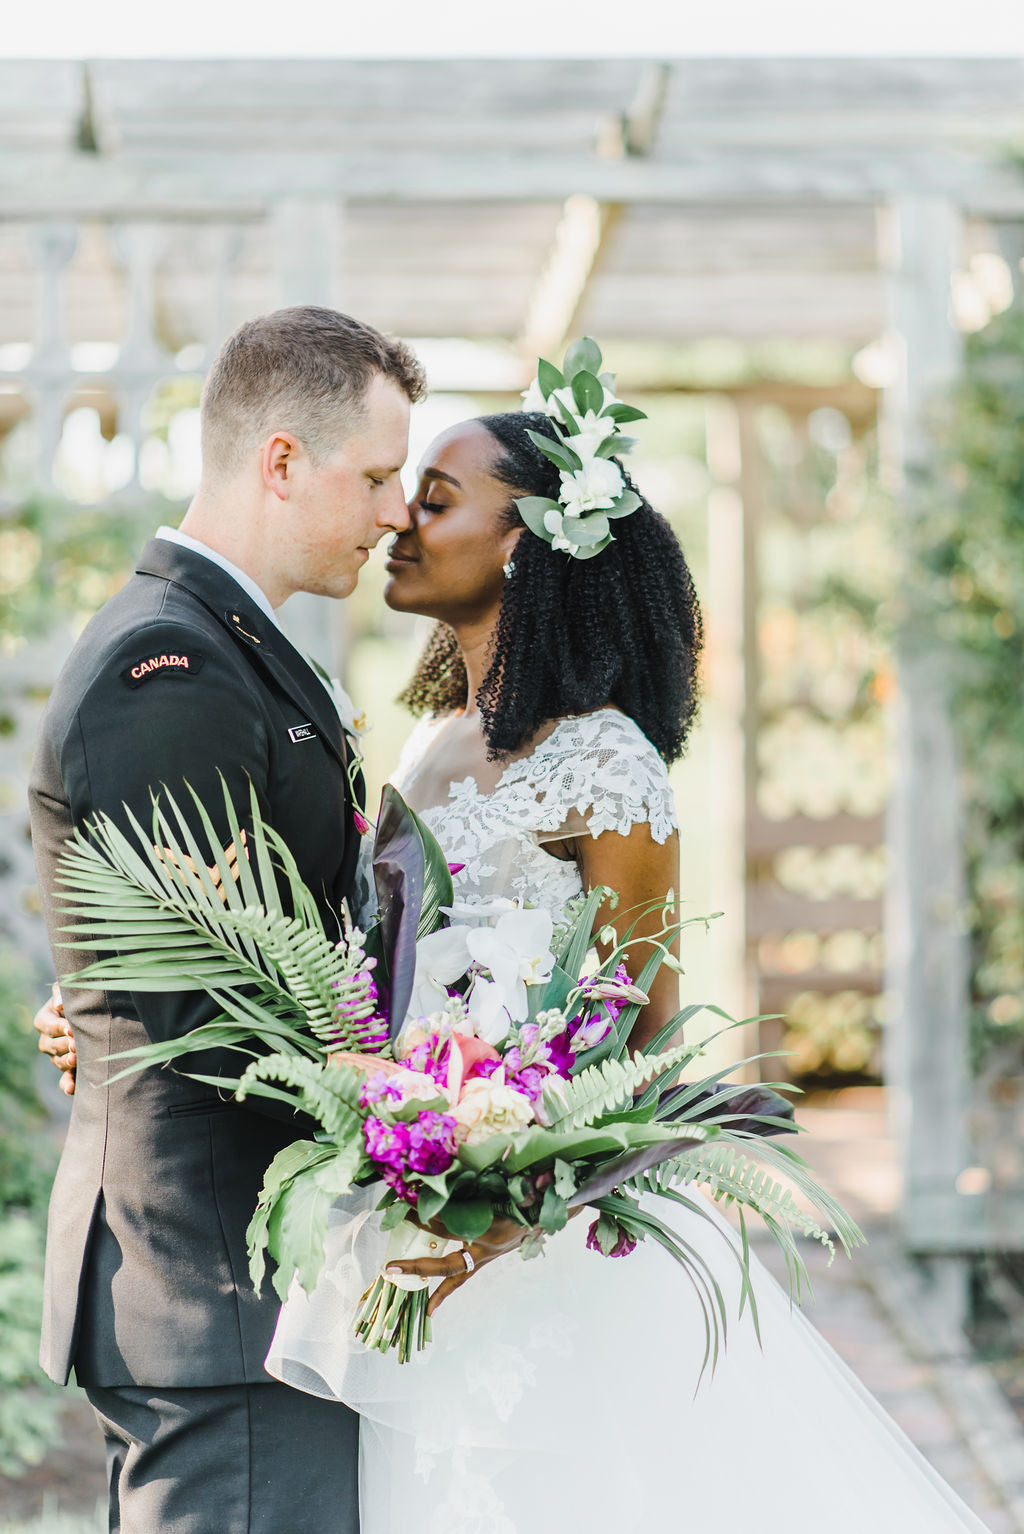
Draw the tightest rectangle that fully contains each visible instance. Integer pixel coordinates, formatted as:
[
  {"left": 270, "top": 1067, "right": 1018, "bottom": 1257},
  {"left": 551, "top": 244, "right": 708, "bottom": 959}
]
[{"left": 392, "top": 709, "right": 678, "bottom": 911}]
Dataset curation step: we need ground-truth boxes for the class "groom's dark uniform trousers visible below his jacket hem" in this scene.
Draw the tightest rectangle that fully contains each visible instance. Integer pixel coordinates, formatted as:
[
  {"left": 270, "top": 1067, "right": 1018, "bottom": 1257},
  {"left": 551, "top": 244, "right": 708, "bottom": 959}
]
[{"left": 86, "top": 1381, "right": 359, "bottom": 1534}]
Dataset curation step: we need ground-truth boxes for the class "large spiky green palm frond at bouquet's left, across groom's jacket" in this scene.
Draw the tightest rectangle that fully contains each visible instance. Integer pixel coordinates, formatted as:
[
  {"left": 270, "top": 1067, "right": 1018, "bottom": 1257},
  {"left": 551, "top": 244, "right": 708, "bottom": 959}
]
[{"left": 58, "top": 784, "right": 383, "bottom": 1063}]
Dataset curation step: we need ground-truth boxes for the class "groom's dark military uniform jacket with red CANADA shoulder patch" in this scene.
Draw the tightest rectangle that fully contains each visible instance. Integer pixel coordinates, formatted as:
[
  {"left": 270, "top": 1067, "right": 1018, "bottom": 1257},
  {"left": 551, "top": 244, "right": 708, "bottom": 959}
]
[{"left": 31, "top": 538, "right": 359, "bottom": 1387}]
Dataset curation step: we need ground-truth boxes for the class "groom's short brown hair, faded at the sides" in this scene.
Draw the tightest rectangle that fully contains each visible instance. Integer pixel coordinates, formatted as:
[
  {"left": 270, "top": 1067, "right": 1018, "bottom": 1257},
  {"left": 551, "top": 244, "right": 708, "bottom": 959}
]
[{"left": 201, "top": 304, "right": 426, "bottom": 479}]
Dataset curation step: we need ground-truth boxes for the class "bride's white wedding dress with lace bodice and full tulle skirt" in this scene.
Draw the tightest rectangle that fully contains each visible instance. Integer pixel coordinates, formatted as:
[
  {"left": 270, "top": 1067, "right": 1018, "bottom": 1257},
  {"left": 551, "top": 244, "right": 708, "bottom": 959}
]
[{"left": 267, "top": 710, "right": 984, "bottom": 1534}]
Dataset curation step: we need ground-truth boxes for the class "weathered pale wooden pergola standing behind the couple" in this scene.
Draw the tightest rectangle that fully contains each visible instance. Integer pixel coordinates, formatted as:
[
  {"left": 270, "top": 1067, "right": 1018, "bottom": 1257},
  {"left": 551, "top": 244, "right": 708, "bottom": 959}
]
[{"left": 0, "top": 60, "right": 1024, "bottom": 1276}]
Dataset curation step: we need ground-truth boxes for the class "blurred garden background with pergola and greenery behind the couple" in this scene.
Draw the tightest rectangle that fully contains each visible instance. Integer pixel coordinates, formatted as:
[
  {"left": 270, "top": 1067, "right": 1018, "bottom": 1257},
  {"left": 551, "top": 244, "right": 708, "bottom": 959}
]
[{"left": 0, "top": 58, "right": 1024, "bottom": 1534}]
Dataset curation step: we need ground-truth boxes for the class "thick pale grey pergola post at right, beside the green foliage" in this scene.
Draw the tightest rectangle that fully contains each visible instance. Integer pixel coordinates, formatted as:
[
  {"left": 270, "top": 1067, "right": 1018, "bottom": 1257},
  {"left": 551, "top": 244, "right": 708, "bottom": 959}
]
[{"left": 883, "top": 196, "right": 969, "bottom": 1319}]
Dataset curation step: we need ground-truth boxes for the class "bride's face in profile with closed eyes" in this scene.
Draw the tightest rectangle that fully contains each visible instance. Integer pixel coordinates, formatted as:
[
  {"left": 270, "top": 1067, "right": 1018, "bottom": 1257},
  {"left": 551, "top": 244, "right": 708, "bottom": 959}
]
[{"left": 385, "top": 420, "right": 521, "bottom": 626}]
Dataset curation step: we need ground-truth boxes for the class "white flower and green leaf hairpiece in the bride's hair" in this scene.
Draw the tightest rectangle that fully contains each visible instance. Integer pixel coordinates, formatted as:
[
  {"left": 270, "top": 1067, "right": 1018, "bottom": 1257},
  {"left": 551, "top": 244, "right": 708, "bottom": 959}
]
[{"left": 515, "top": 336, "right": 647, "bottom": 560}]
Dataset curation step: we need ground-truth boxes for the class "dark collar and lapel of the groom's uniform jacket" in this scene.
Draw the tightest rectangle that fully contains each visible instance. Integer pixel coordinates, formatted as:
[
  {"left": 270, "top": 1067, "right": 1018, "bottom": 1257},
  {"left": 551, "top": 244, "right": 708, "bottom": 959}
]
[{"left": 135, "top": 538, "right": 350, "bottom": 782}]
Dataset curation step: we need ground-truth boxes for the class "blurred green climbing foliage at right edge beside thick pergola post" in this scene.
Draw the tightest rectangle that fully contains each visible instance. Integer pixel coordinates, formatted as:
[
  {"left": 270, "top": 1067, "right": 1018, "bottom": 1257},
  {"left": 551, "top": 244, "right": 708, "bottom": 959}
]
[{"left": 907, "top": 307, "right": 1024, "bottom": 1060}]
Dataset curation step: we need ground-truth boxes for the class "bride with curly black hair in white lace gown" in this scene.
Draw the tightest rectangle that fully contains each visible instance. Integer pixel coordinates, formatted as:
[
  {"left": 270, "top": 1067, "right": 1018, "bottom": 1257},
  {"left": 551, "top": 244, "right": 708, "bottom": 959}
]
[{"left": 267, "top": 401, "right": 983, "bottom": 1534}]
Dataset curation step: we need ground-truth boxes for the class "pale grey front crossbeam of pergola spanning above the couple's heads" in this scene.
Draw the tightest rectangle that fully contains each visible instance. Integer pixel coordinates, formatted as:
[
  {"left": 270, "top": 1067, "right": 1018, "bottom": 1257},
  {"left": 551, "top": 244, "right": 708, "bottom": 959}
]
[{"left": 0, "top": 143, "right": 1024, "bottom": 219}]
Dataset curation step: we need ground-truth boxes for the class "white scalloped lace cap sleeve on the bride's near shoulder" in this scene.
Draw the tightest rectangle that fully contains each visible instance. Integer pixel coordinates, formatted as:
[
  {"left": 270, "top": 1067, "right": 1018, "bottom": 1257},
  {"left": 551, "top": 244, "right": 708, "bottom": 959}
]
[{"left": 501, "top": 709, "right": 678, "bottom": 842}]
